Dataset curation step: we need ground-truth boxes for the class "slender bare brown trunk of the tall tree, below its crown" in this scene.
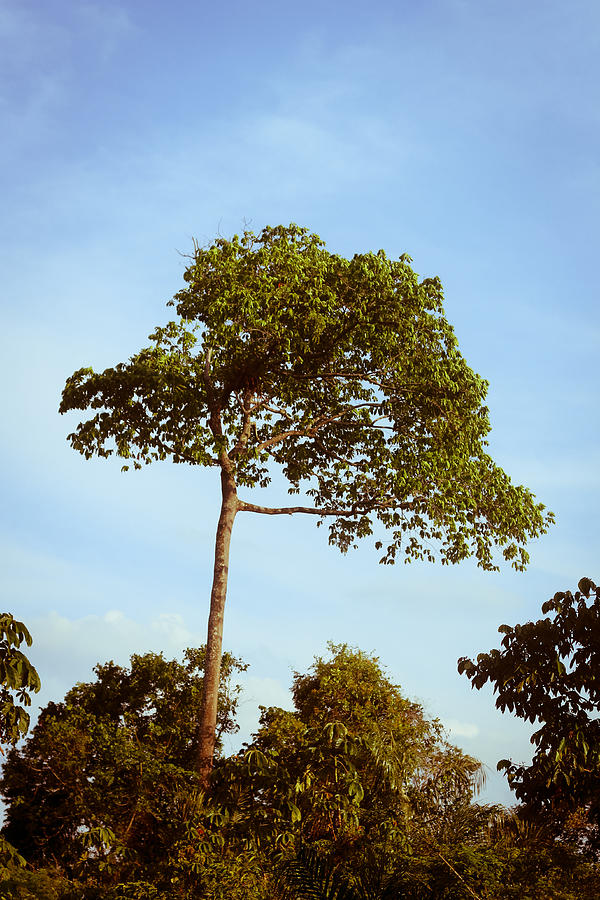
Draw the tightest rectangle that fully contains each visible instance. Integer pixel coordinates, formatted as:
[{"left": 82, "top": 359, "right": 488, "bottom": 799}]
[{"left": 196, "top": 468, "right": 239, "bottom": 790}]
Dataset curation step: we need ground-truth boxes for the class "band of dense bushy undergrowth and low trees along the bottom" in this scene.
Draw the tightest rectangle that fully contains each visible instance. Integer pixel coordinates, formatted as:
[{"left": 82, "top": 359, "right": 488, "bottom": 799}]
[{"left": 0, "top": 645, "right": 600, "bottom": 900}]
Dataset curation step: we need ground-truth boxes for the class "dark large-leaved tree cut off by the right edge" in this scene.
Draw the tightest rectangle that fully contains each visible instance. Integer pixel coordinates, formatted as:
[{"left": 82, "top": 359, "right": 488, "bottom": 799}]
[{"left": 458, "top": 578, "right": 600, "bottom": 843}]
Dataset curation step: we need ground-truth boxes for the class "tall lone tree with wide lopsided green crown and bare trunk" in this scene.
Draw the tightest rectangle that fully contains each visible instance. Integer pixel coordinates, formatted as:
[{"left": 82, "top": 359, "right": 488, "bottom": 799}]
[{"left": 60, "top": 225, "right": 552, "bottom": 783}]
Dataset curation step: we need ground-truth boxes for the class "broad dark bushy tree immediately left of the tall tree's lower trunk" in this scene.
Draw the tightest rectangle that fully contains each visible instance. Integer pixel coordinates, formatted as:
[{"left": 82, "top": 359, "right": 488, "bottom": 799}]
[{"left": 0, "top": 649, "right": 245, "bottom": 881}]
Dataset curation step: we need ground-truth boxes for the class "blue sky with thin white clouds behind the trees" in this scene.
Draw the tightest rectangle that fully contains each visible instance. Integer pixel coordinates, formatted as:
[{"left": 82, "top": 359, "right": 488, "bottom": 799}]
[{"left": 0, "top": 0, "right": 600, "bottom": 802}]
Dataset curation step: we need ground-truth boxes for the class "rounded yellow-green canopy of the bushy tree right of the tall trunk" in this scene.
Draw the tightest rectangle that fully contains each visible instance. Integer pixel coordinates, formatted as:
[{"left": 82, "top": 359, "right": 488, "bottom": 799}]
[{"left": 215, "top": 644, "right": 482, "bottom": 870}]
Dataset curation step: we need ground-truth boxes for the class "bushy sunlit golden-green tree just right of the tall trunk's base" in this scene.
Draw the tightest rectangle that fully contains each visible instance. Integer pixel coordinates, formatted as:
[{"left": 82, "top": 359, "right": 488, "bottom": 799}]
[{"left": 213, "top": 645, "right": 502, "bottom": 898}]
